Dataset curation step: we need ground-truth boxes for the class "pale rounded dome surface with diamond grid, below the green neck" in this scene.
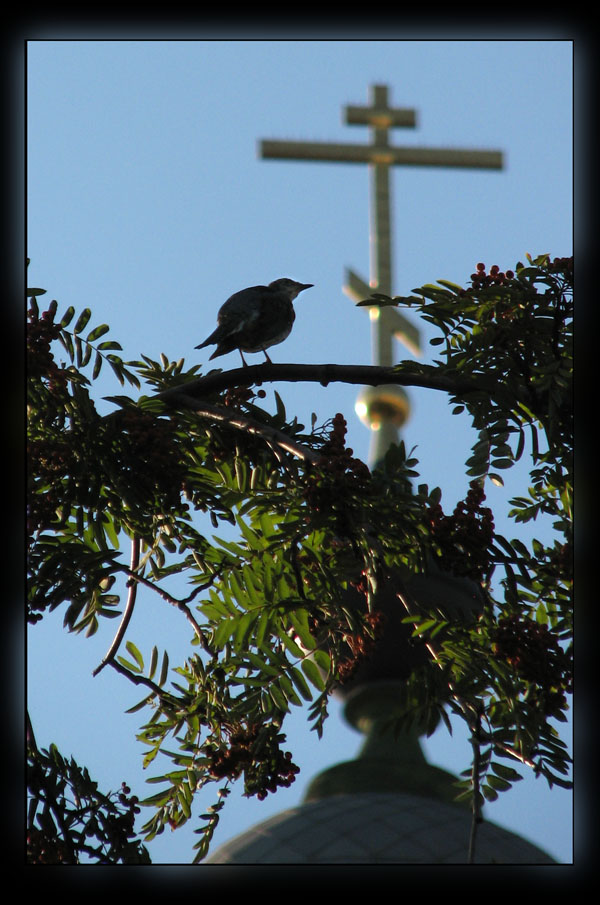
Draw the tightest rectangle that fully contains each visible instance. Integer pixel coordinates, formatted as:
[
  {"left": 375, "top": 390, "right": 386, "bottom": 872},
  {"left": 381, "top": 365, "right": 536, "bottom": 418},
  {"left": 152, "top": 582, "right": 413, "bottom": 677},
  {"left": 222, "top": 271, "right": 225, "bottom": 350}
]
[{"left": 205, "top": 792, "right": 554, "bottom": 864}]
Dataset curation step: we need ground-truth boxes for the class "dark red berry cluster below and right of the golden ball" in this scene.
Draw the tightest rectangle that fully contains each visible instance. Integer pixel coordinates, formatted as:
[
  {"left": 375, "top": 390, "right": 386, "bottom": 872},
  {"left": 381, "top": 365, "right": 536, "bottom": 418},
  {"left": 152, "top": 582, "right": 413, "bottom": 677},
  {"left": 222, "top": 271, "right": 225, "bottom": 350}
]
[{"left": 427, "top": 481, "right": 494, "bottom": 581}]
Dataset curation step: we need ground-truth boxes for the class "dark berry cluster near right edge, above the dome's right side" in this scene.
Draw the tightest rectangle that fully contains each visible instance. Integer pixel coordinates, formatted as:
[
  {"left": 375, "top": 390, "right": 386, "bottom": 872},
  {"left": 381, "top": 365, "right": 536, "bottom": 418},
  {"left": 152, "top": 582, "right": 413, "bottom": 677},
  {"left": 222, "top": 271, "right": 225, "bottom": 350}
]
[{"left": 492, "top": 616, "right": 572, "bottom": 715}]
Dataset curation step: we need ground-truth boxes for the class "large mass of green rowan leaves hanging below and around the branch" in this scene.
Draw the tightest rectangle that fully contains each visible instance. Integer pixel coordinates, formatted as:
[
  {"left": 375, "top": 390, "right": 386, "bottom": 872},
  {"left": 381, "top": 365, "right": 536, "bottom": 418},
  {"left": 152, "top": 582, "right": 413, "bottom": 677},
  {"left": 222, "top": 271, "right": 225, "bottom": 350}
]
[{"left": 28, "top": 257, "right": 572, "bottom": 860}]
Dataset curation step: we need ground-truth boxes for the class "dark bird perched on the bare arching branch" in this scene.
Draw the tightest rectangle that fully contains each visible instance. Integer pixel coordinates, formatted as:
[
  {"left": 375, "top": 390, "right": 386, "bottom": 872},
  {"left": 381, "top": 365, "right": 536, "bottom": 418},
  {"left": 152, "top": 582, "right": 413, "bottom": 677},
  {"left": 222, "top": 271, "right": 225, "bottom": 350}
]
[{"left": 196, "top": 277, "right": 313, "bottom": 367}]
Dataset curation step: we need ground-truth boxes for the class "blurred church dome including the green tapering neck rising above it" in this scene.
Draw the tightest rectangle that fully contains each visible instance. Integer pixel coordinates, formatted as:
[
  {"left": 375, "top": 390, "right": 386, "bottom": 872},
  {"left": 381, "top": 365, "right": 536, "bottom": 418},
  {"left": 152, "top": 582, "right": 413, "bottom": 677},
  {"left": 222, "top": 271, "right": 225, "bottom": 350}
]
[{"left": 205, "top": 682, "right": 555, "bottom": 864}]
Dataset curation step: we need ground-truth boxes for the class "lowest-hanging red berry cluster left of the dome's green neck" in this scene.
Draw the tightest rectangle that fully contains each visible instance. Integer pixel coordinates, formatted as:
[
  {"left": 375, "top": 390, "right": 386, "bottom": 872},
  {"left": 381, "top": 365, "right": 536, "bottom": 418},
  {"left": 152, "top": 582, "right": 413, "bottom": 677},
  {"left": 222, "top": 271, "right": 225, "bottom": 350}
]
[{"left": 204, "top": 724, "right": 300, "bottom": 801}]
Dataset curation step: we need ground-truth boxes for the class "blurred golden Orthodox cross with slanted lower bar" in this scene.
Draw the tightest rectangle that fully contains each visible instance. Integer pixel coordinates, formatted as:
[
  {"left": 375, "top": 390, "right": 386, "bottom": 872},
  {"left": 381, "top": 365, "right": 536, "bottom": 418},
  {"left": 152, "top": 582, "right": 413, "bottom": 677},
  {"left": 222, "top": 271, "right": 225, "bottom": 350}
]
[{"left": 260, "top": 85, "right": 503, "bottom": 460}]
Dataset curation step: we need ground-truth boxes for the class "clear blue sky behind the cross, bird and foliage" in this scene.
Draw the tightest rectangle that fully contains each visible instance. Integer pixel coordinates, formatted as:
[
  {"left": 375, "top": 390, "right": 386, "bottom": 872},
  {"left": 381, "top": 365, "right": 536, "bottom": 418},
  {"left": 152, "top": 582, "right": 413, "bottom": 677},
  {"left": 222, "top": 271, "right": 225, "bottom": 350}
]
[{"left": 27, "top": 40, "right": 573, "bottom": 863}]
